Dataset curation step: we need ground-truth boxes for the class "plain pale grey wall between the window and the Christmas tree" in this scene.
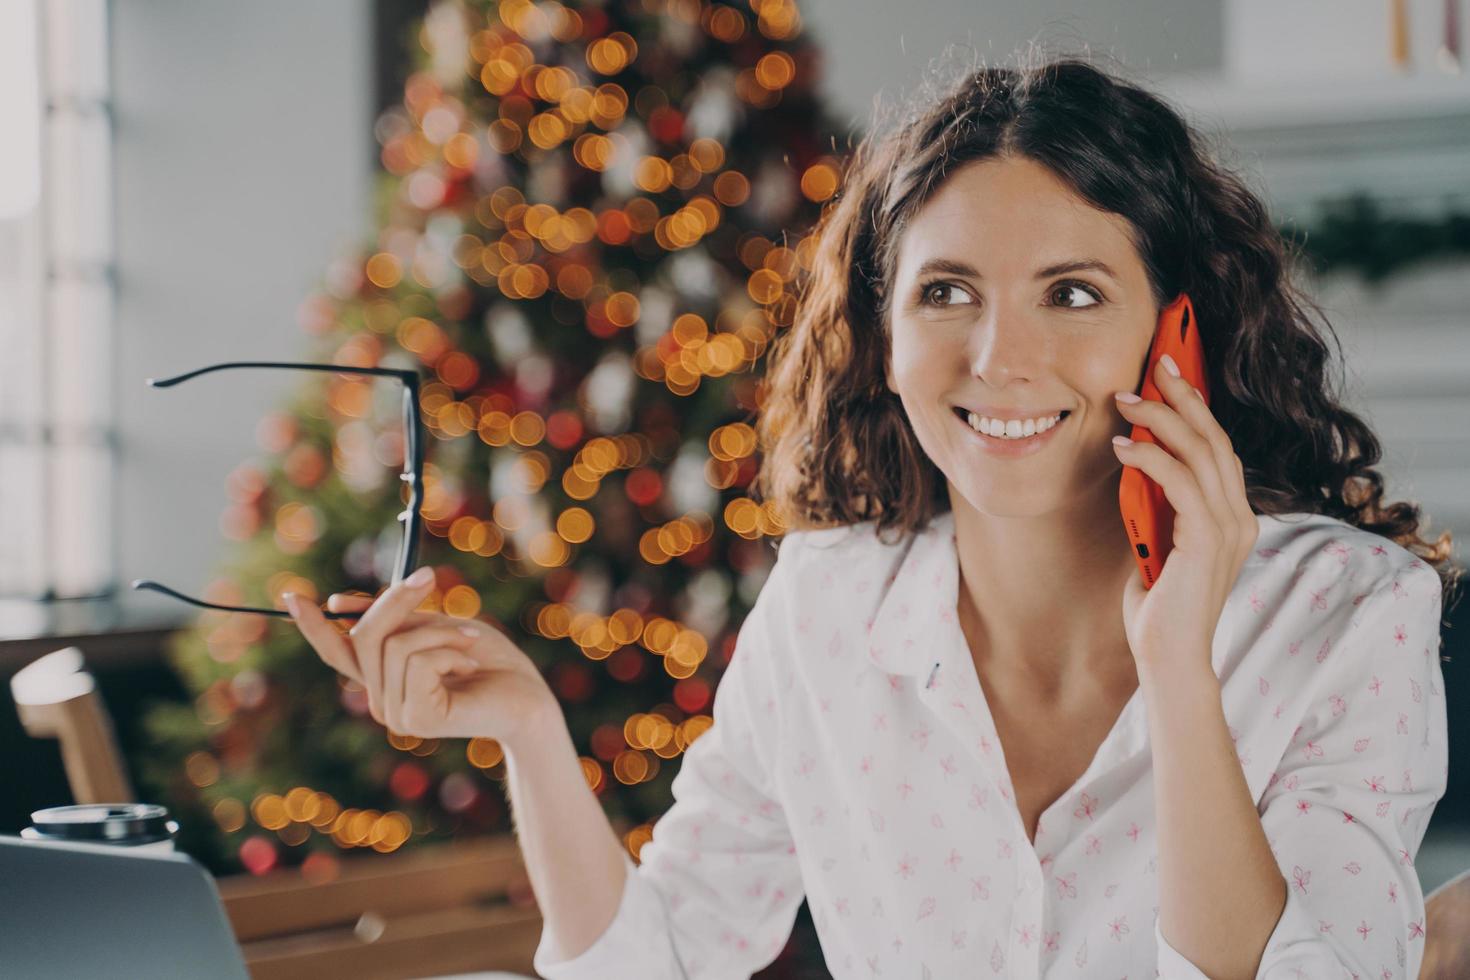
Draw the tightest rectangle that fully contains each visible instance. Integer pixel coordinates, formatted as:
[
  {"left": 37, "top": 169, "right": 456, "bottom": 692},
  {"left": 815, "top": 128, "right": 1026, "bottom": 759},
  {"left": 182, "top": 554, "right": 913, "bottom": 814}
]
[{"left": 112, "top": 0, "right": 375, "bottom": 617}]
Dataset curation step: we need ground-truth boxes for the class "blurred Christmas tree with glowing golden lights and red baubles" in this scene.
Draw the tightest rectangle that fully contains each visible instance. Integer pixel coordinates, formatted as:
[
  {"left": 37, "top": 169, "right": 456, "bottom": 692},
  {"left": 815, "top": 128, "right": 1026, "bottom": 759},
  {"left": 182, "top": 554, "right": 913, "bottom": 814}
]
[{"left": 138, "top": 0, "right": 851, "bottom": 969}]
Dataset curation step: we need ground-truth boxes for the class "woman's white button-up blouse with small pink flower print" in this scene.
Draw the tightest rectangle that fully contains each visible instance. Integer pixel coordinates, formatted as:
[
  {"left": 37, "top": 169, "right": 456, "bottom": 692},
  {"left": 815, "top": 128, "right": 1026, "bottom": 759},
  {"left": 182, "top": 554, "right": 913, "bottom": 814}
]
[{"left": 534, "top": 513, "right": 1449, "bottom": 980}]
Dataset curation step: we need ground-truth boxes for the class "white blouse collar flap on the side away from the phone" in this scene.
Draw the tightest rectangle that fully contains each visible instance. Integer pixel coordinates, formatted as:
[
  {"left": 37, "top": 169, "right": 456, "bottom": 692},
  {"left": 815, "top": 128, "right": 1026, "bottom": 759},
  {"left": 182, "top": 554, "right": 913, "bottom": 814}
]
[{"left": 867, "top": 510, "right": 960, "bottom": 677}]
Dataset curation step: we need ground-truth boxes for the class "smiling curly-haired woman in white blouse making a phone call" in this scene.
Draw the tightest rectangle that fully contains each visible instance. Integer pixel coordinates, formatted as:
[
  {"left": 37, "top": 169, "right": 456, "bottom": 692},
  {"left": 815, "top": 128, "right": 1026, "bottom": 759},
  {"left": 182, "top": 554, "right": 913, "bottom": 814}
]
[{"left": 280, "top": 59, "right": 1451, "bottom": 980}]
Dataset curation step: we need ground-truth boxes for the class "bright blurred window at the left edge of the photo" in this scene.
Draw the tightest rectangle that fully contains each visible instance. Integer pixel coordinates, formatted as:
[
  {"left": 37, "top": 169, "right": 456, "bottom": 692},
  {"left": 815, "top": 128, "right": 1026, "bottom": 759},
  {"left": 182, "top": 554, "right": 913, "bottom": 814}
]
[{"left": 0, "top": 0, "right": 116, "bottom": 614}]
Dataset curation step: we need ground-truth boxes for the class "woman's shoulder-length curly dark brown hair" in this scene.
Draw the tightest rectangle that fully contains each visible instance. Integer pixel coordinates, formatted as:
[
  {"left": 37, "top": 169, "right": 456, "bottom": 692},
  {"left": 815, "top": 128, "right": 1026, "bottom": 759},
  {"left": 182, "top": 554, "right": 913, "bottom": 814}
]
[{"left": 751, "top": 47, "right": 1464, "bottom": 620}]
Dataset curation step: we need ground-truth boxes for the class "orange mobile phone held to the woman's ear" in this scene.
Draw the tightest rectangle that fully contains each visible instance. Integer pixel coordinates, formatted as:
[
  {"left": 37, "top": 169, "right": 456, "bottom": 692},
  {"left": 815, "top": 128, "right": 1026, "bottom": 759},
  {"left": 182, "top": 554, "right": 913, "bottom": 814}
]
[{"left": 1117, "top": 292, "right": 1210, "bottom": 589}]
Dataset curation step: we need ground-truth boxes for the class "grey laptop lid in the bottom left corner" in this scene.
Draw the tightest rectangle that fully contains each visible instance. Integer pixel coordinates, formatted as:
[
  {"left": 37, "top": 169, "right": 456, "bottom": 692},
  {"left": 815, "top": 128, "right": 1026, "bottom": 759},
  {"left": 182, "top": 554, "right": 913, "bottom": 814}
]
[{"left": 0, "top": 835, "right": 250, "bottom": 980}]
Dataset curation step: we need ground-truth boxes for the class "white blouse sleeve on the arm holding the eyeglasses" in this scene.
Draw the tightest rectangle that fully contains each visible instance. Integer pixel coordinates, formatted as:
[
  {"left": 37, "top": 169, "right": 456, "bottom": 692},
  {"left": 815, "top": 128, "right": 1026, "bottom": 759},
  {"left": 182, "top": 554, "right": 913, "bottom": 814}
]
[{"left": 532, "top": 535, "right": 804, "bottom": 980}]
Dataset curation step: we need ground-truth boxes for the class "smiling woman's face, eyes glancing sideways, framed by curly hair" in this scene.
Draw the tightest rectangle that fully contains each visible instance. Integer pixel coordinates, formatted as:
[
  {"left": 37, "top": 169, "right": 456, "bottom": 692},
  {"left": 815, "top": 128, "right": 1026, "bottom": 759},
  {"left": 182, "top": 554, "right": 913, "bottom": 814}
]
[{"left": 886, "top": 159, "right": 1158, "bottom": 516}]
